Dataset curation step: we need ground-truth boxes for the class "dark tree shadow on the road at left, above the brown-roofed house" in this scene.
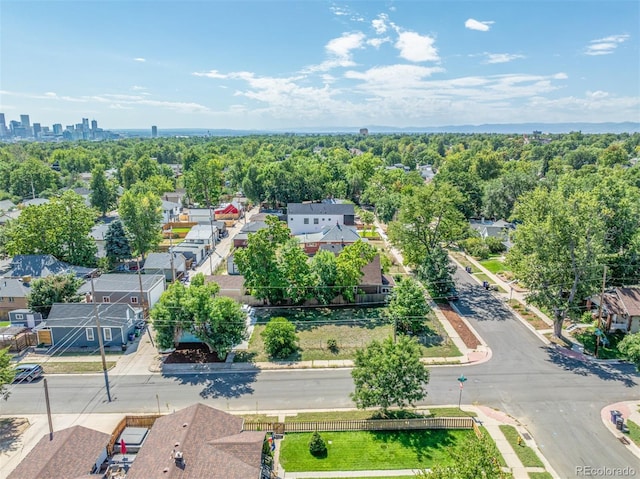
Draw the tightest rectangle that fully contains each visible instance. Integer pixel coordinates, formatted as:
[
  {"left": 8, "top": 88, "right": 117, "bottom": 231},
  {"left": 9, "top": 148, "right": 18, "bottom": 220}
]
[{"left": 162, "top": 369, "right": 258, "bottom": 399}]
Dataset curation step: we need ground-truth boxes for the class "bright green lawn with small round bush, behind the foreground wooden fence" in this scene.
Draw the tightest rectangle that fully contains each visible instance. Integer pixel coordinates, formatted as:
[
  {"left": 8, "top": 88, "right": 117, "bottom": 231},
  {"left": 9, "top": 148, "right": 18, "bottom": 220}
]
[{"left": 280, "top": 429, "right": 474, "bottom": 472}]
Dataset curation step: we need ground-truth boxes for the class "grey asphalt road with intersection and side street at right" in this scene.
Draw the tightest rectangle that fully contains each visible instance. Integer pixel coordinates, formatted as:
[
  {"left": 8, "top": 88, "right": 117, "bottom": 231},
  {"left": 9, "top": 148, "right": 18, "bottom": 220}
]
[{"left": 0, "top": 264, "right": 640, "bottom": 478}]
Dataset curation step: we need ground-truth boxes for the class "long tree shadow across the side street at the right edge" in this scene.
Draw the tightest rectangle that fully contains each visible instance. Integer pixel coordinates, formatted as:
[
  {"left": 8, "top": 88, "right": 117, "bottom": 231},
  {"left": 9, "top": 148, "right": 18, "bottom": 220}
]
[{"left": 544, "top": 346, "right": 638, "bottom": 387}]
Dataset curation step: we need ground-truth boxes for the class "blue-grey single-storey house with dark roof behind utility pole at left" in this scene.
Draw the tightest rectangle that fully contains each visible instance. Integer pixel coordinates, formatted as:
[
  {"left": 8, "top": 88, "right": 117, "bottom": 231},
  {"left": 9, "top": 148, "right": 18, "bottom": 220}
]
[{"left": 36, "top": 303, "right": 142, "bottom": 350}]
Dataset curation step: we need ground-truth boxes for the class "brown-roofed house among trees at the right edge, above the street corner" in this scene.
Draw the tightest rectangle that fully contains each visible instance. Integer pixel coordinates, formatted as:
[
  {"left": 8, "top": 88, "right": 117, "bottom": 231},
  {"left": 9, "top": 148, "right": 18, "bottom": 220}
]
[{"left": 591, "top": 286, "right": 640, "bottom": 333}]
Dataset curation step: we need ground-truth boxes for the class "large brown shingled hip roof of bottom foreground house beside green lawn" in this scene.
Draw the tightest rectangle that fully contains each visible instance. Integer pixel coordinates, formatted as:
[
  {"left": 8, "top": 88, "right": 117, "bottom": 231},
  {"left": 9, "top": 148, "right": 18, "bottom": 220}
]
[{"left": 127, "top": 404, "right": 271, "bottom": 479}]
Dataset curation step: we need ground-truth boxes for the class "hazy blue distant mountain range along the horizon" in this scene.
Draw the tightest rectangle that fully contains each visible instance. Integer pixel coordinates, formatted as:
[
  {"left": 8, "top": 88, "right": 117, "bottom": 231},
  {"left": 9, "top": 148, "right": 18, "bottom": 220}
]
[{"left": 111, "top": 121, "right": 640, "bottom": 137}]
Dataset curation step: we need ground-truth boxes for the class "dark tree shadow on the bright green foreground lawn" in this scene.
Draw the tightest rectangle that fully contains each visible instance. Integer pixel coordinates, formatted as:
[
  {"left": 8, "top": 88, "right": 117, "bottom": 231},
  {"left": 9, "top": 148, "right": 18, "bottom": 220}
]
[{"left": 370, "top": 429, "right": 458, "bottom": 462}]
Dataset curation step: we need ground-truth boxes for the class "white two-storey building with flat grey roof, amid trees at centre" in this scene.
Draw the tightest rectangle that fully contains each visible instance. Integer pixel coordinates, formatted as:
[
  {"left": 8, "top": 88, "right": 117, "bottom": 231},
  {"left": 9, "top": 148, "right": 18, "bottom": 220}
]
[{"left": 287, "top": 203, "right": 356, "bottom": 235}]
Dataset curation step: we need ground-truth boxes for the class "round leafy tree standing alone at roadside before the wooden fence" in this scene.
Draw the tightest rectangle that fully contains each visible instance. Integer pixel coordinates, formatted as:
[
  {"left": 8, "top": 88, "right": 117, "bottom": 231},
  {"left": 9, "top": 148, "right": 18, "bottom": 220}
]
[{"left": 351, "top": 336, "right": 429, "bottom": 413}]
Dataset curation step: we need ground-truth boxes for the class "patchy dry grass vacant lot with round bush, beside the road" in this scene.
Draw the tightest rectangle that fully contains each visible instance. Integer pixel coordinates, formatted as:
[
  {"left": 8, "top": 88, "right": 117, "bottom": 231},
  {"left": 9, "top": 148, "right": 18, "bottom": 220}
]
[{"left": 235, "top": 307, "right": 460, "bottom": 362}]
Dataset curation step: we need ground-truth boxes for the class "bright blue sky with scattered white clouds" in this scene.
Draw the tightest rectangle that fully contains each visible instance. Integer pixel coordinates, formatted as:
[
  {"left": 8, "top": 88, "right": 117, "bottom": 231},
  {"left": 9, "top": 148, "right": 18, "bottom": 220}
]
[{"left": 0, "top": 0, "right": 640, "bottom": 130}]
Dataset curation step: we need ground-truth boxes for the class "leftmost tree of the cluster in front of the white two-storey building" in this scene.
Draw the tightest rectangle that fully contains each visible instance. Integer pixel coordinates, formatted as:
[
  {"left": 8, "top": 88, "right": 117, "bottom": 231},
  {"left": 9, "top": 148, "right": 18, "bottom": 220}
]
[{"left": 234, "top": 216, "right": 290, "bottom": 304}]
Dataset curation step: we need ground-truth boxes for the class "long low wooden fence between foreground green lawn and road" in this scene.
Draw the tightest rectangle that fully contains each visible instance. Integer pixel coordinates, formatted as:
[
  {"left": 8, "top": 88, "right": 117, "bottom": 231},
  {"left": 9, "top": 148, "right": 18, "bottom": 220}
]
[{"left": 243, "top": 417, "right": 474, "bottom": 434}]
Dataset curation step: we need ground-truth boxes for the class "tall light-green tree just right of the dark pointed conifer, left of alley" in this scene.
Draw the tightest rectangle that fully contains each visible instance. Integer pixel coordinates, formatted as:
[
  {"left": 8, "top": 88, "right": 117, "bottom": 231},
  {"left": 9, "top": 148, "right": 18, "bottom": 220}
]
[{"left": 118, "top": 191, "right": 162, "bottom": 259}]
